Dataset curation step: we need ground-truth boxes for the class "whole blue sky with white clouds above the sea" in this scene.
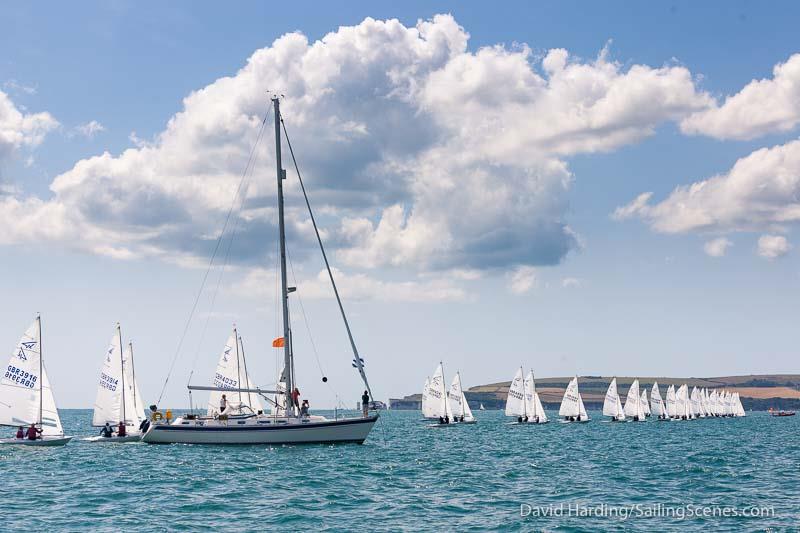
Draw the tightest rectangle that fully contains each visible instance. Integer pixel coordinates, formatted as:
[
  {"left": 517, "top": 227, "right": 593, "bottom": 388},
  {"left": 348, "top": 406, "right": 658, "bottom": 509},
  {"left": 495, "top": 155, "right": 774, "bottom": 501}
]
[{"left": 0, "top": 2, "right": 800, "bottom": 408}]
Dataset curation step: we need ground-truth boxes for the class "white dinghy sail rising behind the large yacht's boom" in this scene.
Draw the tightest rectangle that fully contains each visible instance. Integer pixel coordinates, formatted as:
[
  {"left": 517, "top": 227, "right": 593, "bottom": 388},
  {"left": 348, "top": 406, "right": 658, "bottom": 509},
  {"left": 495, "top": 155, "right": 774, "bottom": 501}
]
[{"left": 207, "top": 330, "right": 262, "bottom": 416}]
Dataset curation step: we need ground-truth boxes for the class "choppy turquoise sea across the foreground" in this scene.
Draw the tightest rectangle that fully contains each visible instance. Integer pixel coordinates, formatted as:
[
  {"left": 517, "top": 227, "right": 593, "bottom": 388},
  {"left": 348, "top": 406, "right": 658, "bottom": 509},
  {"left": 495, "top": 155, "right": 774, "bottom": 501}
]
[{"left": 0, "top": 410, "right": 800, "bottom": 531}]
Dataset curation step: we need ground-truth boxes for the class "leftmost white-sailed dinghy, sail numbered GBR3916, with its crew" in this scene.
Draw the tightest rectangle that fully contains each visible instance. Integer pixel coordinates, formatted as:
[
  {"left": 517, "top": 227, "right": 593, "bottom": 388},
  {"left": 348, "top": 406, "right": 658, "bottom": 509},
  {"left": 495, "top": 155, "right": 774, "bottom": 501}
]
[{"left": 0, "top": 316, "right": 72, "bottom": 446}]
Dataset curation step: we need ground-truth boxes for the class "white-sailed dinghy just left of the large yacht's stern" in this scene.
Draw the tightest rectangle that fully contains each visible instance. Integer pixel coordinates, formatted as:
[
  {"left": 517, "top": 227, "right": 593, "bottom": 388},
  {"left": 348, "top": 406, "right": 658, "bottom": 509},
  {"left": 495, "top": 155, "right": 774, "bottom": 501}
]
[{"left": 84, "top": 323, "right": 146, "bottom": 443}]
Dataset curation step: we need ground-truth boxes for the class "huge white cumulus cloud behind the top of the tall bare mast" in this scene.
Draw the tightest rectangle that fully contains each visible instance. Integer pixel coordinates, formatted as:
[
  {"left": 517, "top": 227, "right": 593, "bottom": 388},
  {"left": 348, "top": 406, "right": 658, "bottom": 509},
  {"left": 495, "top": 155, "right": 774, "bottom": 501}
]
[{"left": 0, "top": 15, "right": 713, "bottom": 275}]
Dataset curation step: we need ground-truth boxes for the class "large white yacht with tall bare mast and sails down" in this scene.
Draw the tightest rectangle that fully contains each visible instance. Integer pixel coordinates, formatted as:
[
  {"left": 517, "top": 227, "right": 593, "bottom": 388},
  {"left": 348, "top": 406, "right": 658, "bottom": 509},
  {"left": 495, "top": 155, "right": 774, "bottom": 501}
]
[{"left": 142, "top": 96, "right": 378, "bottom": 444}]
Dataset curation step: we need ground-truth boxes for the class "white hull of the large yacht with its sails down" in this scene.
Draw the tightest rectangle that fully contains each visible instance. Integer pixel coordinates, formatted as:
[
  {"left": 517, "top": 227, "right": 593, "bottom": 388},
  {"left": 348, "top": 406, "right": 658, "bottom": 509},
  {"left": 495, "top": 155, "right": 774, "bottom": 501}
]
[{"left": 142, "top": 415, "right": 378, "bottom": 444}]
